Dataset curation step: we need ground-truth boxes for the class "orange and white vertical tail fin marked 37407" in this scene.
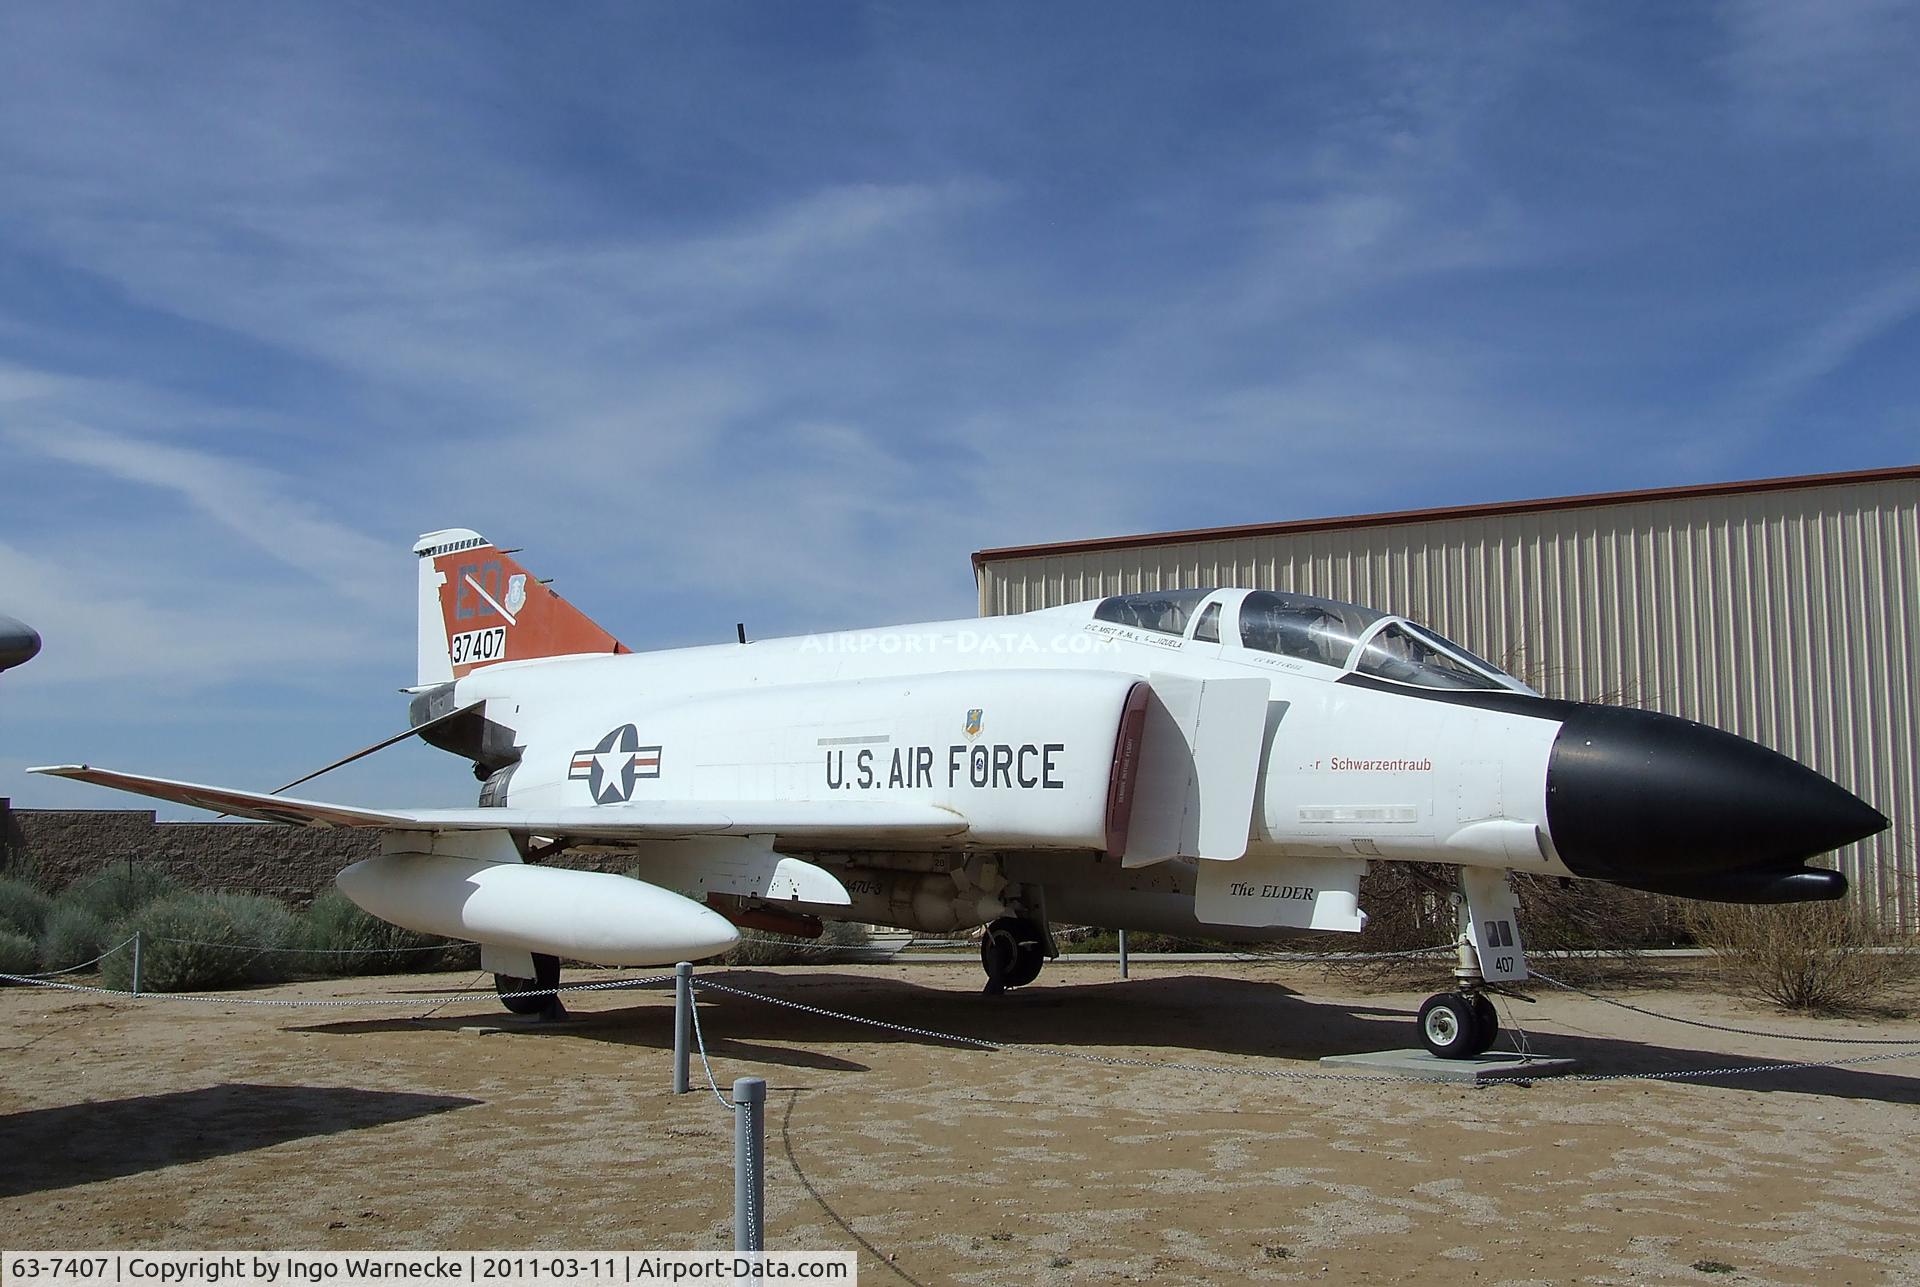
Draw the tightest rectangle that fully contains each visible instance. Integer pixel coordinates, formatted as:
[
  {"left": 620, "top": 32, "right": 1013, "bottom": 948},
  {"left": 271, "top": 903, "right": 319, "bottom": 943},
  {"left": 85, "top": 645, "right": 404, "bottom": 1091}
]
[{"left": 413, "top": 528, "right": 628, "bottom": 688}]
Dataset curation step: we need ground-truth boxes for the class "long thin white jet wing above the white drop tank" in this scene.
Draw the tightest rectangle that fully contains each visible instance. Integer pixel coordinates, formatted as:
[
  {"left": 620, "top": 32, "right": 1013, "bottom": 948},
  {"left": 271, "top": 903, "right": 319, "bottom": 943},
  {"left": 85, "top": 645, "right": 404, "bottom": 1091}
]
[{"left": 27, "top": 765, "right": 968, "bottom": 845}]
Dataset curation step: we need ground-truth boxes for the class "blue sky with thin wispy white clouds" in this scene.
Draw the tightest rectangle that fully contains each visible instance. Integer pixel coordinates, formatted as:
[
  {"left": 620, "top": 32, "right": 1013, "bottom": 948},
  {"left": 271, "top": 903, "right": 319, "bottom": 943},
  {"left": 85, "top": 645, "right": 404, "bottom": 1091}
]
[{"left": 0, "top": 0, "right": 1920, "bottom": 816}]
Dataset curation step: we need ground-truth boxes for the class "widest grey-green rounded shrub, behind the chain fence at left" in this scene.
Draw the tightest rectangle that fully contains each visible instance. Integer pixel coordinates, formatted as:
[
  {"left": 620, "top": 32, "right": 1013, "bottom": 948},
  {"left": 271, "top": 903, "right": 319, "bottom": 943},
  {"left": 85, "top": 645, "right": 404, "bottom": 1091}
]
[{"left": 100, "top": 893, "right": 296, "bottom": 991}]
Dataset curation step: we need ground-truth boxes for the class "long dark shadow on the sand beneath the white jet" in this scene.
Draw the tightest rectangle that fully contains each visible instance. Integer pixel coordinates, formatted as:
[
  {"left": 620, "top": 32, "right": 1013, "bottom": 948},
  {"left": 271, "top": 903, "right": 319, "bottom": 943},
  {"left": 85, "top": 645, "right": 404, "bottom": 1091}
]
[{"left": 291, "top": 970, "right": 1920, "bottom": 1105}]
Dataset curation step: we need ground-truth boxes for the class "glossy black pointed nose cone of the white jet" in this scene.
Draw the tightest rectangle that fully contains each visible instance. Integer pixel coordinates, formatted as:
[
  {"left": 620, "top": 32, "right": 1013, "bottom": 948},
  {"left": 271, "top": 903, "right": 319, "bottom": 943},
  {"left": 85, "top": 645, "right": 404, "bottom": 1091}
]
[{"left": 1548, "top": 705, "right": 1887, "bottom": 903}]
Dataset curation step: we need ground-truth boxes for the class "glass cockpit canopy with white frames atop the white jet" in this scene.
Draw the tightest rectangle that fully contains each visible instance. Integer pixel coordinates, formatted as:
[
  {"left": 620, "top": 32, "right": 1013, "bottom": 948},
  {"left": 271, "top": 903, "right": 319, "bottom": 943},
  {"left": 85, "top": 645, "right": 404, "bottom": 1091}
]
[{"left": 1092, "top": 590, "right": 1532, "bottom": 692}]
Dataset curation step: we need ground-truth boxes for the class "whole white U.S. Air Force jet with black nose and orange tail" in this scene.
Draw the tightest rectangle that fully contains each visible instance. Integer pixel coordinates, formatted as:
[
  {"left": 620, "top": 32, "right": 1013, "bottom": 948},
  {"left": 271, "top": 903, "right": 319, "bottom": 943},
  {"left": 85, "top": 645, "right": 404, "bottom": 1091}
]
[{"left": 35, "top": 528, "right": 1887, "bottom": 1058}]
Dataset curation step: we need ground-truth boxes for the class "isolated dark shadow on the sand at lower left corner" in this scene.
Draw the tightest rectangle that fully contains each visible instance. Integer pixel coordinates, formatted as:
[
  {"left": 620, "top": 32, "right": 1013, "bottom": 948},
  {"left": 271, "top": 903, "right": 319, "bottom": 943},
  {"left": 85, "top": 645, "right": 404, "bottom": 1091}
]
[{"left": 0, "top": 1083, "right": 480, "bottom": 1197}]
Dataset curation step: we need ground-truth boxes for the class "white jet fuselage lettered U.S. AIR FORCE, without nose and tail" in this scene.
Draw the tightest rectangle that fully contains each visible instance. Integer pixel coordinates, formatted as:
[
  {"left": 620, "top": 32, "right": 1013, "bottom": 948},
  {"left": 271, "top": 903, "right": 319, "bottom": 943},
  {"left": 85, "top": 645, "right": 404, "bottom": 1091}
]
[{"left": 453, "top": 592, "right": 1567, "bottom": 939}]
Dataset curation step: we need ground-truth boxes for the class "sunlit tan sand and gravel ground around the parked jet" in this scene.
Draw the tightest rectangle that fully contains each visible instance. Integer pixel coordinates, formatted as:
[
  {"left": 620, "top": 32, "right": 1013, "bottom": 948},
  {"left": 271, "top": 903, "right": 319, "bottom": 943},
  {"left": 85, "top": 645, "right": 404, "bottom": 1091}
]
[{"left": 0, "top": 964, "right": 1920, "bottom": 1285}]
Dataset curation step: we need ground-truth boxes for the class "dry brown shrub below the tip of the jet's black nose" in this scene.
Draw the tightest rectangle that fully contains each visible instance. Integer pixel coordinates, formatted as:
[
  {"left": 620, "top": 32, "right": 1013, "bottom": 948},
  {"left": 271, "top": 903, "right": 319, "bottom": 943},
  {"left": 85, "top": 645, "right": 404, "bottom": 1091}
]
[{"left": 1690, "top": 903, "right": 1905, "bottom": 1012}]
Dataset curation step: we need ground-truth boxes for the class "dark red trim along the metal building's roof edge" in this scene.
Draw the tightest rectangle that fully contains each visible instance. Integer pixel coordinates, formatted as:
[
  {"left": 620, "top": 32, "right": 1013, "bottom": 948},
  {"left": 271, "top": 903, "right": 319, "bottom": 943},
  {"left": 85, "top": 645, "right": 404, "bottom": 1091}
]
[{"left": 973, "top": 465, "right": 1920, "bottom": 572}]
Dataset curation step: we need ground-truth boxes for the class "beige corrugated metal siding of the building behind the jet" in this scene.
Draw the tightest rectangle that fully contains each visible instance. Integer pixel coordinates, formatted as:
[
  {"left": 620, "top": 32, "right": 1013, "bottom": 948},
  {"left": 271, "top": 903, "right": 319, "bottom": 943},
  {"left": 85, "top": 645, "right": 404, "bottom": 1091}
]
[{"left": 979, "top": 478, "right": 1920, "bottom": 930}]
